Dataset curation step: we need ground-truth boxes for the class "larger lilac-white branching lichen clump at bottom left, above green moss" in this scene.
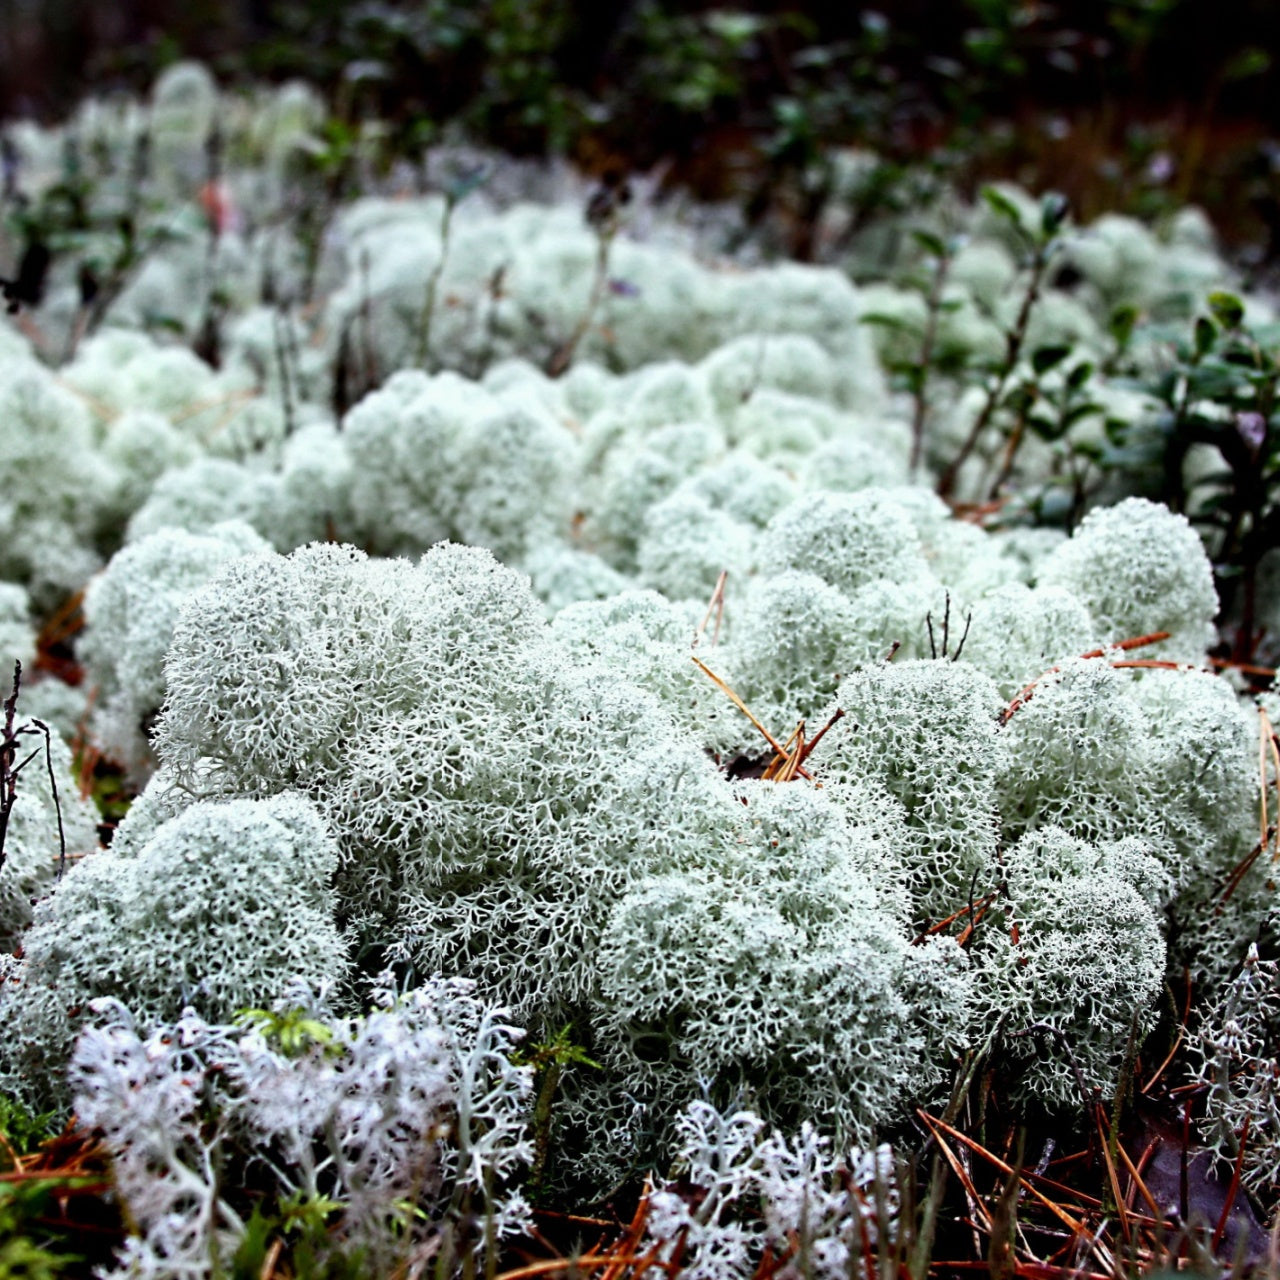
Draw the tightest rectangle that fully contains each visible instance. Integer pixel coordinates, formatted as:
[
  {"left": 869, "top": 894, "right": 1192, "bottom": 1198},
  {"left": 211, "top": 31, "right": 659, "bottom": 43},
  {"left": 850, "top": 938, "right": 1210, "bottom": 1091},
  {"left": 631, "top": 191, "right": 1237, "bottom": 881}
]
[{"left": 70, "top": 979, "right": 532, "bottom": 1277}]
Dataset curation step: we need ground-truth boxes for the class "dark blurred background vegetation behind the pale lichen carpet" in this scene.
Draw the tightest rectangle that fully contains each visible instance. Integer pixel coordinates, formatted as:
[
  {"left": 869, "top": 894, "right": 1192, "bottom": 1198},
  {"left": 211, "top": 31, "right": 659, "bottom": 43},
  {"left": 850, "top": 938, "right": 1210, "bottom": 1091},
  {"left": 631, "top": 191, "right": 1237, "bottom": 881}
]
[{"left": 0, "top": 0, "right": 1280, "bottom": 259}]
